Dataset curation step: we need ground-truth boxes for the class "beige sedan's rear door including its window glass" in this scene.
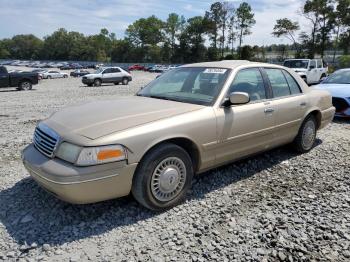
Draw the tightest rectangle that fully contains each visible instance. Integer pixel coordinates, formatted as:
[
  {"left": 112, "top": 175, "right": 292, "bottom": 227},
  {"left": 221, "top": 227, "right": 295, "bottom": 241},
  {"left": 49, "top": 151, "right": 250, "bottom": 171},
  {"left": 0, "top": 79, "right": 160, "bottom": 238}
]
[{"left": 264, "top": 68, "right": 307, "bottom": 145}]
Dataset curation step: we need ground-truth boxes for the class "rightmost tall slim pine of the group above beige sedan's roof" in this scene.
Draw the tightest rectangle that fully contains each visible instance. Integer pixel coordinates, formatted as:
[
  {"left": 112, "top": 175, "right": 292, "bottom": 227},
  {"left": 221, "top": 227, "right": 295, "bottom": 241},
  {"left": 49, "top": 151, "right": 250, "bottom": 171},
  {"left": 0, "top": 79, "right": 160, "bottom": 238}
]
[{"left": 236, "top": 2, "right": 256, "bottom": 55}]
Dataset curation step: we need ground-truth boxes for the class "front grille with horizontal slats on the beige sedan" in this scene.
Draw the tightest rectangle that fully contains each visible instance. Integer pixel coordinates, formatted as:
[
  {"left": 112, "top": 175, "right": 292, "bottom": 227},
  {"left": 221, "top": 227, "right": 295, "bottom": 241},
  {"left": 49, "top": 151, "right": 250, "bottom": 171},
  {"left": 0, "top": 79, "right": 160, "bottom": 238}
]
[{"left": 33, "top": 124, "right": 59, "bottom": 157}]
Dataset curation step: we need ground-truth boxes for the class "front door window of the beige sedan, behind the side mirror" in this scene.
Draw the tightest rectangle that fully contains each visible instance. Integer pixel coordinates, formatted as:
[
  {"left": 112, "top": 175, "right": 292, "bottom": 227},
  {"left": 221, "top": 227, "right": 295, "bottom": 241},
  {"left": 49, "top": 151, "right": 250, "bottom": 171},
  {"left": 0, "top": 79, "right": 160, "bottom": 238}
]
[{"left": 229, "top": 68, "right": 266, "bottom": 101}]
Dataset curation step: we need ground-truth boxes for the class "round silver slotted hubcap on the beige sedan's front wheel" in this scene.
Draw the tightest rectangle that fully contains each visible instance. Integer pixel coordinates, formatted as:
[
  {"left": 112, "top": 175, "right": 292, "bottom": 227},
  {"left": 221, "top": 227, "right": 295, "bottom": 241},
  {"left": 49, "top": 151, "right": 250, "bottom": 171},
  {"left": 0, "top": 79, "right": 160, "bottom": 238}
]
[{"left": 151, "top": 157, "right": 186, "bottom": 202}]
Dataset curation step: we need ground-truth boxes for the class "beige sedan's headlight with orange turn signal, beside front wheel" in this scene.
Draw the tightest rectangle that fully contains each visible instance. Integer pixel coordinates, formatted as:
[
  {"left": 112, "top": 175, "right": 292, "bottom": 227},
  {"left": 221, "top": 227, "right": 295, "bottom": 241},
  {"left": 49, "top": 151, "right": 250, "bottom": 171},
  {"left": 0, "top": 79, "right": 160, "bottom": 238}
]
[{"left": 76, "top": 145, "right": 126, "bottom": 166}]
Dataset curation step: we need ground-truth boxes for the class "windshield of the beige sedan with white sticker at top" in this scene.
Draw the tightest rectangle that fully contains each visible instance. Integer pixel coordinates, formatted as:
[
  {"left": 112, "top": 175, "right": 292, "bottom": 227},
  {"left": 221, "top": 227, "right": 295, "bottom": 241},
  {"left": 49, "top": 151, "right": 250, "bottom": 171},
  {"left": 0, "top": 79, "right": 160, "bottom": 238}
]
[{"left": 137, "top": 67, "right": 230, "bottom": 105}]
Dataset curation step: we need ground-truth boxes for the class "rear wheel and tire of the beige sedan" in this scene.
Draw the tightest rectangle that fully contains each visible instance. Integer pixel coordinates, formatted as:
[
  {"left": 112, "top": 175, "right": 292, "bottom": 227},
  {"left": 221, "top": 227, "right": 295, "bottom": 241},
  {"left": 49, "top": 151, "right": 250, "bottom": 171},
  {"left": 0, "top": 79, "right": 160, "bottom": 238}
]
[{"left": 292, "top": 115, "right": 317, "bottom": 153}]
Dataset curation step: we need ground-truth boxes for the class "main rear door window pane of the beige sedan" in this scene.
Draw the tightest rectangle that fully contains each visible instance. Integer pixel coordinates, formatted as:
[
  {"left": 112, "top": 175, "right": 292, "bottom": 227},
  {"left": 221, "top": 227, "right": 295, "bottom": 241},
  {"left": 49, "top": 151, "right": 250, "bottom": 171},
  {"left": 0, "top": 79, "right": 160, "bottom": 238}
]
[{"left": 265, "top": 68, "right": 290, "bottom": 97}]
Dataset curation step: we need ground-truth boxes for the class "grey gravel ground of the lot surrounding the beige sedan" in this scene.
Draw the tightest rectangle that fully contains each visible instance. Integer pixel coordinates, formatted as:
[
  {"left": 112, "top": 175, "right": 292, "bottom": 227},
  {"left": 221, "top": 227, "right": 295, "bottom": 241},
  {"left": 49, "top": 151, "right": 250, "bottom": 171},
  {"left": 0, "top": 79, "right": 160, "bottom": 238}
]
[{"left": 0, "top": 68, "right": 350, "bottom": 261}]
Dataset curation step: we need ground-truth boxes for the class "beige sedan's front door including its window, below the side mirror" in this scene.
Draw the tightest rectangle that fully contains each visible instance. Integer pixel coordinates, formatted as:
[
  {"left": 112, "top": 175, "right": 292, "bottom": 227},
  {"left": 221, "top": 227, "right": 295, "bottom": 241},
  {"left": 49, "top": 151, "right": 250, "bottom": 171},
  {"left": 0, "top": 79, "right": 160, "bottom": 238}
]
[{"left": 216, "top": 68, "right": 275, "bottom": 164}]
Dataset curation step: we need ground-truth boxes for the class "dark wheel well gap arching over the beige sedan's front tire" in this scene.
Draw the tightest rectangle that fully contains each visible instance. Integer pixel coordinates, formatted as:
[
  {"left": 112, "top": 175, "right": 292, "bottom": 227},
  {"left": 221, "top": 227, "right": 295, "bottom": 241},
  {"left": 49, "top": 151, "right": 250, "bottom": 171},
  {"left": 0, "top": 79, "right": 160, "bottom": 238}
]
[{"left": 141, "top": 137, "right": 200, "bottom": 172}]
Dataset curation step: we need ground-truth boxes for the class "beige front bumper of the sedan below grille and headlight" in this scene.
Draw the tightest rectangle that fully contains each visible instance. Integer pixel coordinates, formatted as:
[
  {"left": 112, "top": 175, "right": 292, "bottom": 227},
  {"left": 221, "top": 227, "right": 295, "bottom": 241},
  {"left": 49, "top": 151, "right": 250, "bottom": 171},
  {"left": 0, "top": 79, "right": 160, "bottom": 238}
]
[{"left": 22, "top": 144, "right": 137, "bottom": 204}]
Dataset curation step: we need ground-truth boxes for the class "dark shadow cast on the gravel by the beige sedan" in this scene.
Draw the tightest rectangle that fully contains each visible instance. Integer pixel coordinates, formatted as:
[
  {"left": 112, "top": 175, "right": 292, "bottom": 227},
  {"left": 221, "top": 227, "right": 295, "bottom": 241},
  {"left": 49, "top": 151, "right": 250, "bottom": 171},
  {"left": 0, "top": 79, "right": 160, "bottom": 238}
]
[{"left": 0, "top": 140, "right": 322, "bottom": 249}]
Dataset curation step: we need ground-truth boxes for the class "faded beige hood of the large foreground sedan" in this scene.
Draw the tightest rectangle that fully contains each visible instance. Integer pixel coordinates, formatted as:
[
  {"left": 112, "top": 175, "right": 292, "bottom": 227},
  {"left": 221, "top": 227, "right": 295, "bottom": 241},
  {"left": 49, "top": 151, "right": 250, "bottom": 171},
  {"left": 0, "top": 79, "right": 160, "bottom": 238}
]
[{"left": 44, "top": 96, "right": 204, "bottom": 139}]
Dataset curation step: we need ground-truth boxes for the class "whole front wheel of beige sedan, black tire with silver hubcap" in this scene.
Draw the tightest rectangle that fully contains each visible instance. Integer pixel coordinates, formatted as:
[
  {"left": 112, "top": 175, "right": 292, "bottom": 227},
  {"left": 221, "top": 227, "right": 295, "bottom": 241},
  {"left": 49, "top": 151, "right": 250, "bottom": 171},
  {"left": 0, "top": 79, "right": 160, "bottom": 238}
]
[{"left": 131, "top": 143, "right": 193, "bottom": 211}]
